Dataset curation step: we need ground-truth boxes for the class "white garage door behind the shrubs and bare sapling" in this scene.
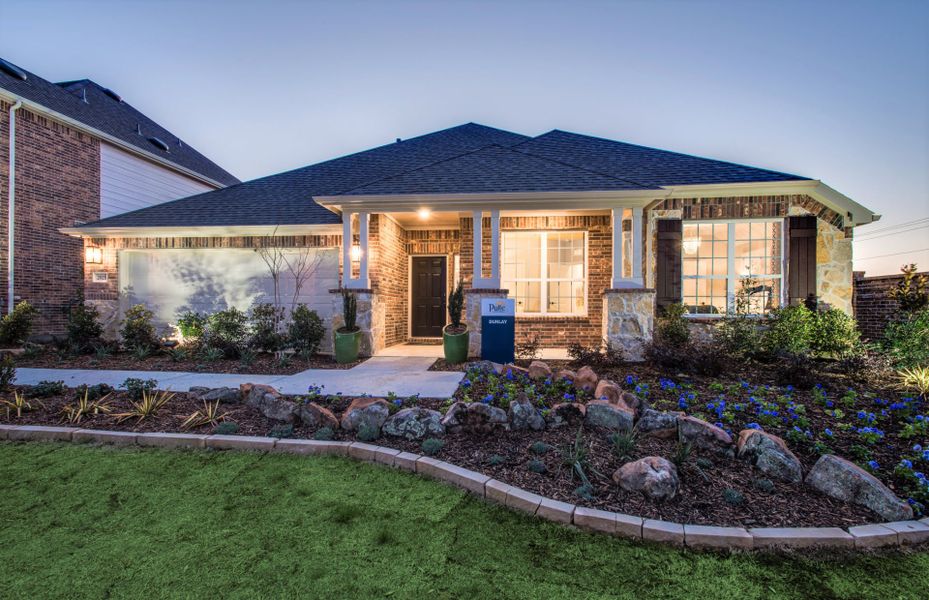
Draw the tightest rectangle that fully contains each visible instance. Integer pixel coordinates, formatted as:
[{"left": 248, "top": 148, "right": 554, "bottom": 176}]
[{"left": 119, "top": 248, "right": 339, "bottom": 336}]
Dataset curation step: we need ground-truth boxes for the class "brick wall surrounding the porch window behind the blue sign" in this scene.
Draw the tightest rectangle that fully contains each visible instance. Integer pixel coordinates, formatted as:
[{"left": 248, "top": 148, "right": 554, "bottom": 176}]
[{"left": 461, "top": 215, "right": 613, "bottom": 348}]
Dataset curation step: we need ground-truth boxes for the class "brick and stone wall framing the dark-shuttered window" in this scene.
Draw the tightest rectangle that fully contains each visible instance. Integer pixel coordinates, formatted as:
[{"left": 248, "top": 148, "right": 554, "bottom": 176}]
[{"left": 645, "top": 195, "right": 852, "bottom": 314}]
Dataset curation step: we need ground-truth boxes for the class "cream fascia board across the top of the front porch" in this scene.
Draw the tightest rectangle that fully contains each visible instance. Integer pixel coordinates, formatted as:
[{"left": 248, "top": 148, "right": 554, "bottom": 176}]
[{"left": 314, "top": 190, "right": 667, "bottom": 212}]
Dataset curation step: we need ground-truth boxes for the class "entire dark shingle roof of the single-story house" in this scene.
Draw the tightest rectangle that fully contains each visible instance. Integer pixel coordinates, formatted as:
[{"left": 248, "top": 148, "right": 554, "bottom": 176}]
[{"left": 74, "top": 123, "right": 805, "bottom": 227}]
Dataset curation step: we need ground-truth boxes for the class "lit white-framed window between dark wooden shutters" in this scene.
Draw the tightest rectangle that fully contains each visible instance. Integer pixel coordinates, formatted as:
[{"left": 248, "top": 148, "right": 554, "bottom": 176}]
[{"left": 681, "top": 220, "right": 784, "bottom": 315}]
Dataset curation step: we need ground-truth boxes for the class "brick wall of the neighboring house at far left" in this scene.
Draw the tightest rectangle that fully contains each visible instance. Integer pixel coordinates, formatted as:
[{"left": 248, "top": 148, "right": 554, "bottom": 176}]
[{"left": 0, "top": 102, "right": 100, "bottom": 333}]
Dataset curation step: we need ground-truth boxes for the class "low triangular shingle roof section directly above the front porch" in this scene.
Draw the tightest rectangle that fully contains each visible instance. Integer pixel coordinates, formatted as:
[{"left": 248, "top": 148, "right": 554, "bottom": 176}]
[{"left": 345, "top": 145, "right": 654, "bottom": 195}]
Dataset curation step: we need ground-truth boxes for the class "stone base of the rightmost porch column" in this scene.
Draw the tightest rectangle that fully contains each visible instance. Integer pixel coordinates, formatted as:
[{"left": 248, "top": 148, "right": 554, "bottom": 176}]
[{"left": 603, "top": 288, "right": 655, "bottom": 361}]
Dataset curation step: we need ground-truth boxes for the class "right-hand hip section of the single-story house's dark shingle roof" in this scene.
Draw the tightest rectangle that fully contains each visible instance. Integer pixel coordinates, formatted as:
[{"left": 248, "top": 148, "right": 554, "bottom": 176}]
[{"left": 515, "top": 129, "right": 806, "bottom": 186}]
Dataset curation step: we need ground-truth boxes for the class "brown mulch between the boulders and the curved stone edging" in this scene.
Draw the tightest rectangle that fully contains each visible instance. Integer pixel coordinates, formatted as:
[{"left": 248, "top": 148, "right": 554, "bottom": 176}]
[{"left": 0, "top": 387, "right": 880, "bottom": 527}]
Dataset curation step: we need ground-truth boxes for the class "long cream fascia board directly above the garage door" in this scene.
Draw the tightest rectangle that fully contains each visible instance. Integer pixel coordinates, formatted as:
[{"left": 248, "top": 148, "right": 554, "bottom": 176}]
[{"left": 58, "top": 224, "right": 342, "bottom": 238}]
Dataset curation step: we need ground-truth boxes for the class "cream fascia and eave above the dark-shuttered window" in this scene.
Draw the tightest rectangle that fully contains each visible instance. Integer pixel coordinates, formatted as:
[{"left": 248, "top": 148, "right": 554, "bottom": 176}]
[{"left": 666, "top": 179, "right": 881, "bottom": 227}]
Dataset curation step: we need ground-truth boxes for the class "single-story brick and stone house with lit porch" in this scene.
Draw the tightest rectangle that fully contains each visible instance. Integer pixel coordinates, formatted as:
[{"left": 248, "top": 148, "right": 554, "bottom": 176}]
[{"left": 62, "top": 123, "right": 879, "bottom": 354}]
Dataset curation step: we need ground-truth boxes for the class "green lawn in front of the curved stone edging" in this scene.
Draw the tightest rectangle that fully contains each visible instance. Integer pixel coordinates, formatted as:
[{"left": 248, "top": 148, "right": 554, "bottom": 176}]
[{"left": 0, "top": 442, "right": 929, "bottom": 600}]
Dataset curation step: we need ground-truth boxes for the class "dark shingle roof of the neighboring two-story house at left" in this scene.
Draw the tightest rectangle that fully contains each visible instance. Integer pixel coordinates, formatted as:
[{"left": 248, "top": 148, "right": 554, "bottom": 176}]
[{"left": 0, "top": 59, "right": 239, "bottom": 185}]
